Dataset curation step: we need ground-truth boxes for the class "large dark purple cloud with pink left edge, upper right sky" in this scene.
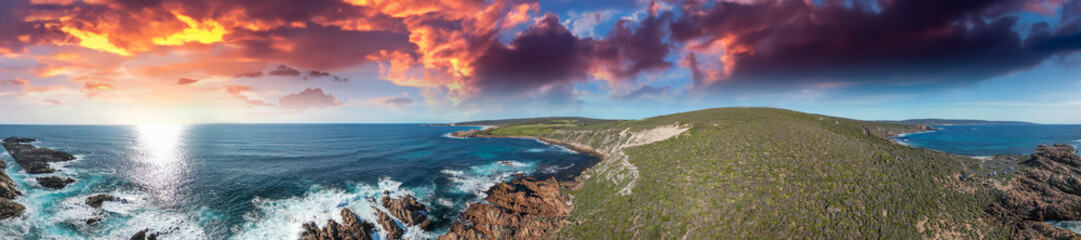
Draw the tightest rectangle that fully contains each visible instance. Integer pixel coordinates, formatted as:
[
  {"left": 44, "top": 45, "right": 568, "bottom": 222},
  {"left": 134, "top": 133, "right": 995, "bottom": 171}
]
[{"left": 670, "top": 0, "right": 1081, "bottom": 88}]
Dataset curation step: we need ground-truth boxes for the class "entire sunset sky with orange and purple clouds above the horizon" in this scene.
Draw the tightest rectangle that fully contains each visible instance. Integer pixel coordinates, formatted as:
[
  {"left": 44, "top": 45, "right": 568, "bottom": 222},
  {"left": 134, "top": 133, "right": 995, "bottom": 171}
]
[{"left": 0, "top": 0, "right": 1081, "bottom": 124}]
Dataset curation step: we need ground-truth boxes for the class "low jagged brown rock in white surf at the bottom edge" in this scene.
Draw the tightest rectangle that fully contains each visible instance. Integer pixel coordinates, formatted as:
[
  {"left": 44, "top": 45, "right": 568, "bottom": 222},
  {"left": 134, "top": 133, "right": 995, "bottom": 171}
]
[{"left": 301, "top": 209, "right": 375, "bottom": 240}]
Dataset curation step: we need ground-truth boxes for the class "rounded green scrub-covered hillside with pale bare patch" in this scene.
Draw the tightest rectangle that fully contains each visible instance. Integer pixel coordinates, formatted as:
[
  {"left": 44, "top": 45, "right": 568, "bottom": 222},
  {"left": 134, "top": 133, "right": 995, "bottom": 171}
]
[{"left": 481, "top": 108, "right": 1007, "bottom": 239}]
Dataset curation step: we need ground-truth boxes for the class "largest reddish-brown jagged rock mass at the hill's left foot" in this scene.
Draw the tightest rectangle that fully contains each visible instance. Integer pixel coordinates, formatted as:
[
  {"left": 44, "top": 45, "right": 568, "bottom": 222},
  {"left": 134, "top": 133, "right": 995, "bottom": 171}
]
[{"left": 439, "top": 175, "right": 571, "bottom": 240}]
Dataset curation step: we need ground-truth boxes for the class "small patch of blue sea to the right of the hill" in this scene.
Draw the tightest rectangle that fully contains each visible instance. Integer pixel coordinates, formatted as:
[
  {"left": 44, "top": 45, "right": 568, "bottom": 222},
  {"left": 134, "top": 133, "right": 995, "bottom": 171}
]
[{"left": 895, "top": 124, "right": 1081, "bottom": 157}]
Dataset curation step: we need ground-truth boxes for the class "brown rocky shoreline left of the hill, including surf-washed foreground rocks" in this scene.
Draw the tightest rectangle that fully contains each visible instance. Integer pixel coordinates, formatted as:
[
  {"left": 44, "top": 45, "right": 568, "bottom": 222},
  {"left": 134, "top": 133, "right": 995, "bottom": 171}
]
[{"left": 291, "top": 130, "right": 606, "bottom": 240}]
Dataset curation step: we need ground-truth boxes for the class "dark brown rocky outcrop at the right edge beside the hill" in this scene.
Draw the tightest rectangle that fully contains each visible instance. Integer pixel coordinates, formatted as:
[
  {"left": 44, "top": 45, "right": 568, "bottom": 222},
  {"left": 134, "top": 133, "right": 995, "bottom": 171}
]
[{"left": 987, "top": 144, "right": 1081, "bottom": 239}]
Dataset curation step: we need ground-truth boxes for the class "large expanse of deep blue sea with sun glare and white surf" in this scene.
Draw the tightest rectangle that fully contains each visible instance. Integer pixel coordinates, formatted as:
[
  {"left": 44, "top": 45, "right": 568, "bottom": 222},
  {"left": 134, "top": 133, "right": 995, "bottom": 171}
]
[{"left": 0, "top": 124, "right": 597, "bottom": 239}]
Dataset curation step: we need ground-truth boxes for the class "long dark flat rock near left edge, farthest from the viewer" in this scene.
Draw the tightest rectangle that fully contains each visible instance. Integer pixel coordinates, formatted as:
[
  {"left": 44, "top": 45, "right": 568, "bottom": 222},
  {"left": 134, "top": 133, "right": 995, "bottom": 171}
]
[{"left": 2, "top": 136, "right": 75, "bottom": 174}]
